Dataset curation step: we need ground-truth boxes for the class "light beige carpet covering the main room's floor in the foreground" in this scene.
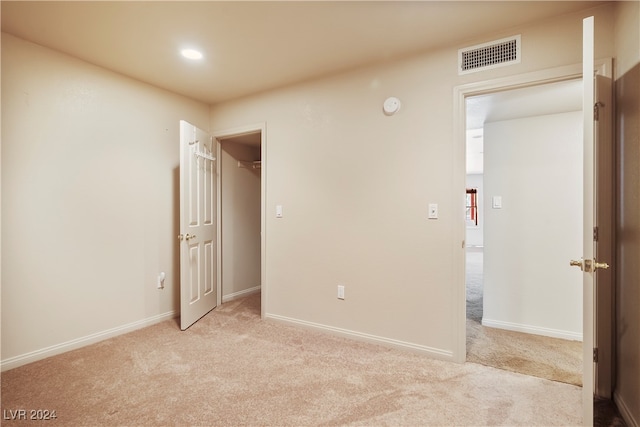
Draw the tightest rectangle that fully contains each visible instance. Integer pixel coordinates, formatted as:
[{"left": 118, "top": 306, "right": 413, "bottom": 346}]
[{"left": 2, "top": 295, "right": 581, "bottom": 426}]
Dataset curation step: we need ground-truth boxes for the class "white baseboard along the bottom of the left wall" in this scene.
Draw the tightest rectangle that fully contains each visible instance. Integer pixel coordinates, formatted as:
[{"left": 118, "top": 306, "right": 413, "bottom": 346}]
[{"left": 0, "top": 310, "right": 179, "bottom": 372}]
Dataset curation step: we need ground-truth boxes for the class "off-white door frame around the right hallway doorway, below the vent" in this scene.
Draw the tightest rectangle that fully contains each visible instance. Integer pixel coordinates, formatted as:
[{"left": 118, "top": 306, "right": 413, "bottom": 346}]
[{"left": 452, "top": 58, "right": 613, "bottom": 363}]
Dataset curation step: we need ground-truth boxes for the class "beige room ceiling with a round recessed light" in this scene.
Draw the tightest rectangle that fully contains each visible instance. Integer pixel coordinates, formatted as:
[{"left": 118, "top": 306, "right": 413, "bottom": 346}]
[{"left": 0, "top": 1, "right": 602, "bottom": 104}]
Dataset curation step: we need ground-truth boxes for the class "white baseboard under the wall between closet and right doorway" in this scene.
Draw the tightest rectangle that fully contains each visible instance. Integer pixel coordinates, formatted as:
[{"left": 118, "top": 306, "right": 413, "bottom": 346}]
[{"left": 265, "top": 314, "right": 454, "bottom": 361}]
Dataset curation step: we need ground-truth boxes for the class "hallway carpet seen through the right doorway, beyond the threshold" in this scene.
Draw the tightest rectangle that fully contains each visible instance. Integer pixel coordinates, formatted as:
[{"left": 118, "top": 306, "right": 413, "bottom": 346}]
[{"left": 467, "top": 249, "right": 582, "bottom": 386}]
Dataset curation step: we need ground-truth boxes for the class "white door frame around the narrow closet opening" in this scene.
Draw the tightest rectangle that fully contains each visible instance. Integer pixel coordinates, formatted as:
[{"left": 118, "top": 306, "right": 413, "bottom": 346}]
[{"left": 211, "top": 122, "right": 268, "bottom": 319}]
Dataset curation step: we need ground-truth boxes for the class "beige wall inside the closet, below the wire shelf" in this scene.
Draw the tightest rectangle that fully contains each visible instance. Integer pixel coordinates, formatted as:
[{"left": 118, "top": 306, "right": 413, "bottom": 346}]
[{"left": 220, "top": 140, "right": 261, "bottom": 301}]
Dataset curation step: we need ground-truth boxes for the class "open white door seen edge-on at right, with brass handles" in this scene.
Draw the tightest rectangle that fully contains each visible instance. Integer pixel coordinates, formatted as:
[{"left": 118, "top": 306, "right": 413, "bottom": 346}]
[{"left": 570, "top": 17, "right": 610, "bottom": 425}]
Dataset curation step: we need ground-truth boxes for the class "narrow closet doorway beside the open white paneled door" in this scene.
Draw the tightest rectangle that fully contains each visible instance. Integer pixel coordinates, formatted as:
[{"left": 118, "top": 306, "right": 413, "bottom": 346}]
[{"left": 215, "top": 127, "right": 265, "bottom": 315}]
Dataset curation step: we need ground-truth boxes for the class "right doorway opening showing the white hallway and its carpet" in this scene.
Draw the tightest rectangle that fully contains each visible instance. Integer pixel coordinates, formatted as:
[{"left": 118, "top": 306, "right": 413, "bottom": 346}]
[{"left": 464, "top": 78, "right": 583, "bottom": 385}]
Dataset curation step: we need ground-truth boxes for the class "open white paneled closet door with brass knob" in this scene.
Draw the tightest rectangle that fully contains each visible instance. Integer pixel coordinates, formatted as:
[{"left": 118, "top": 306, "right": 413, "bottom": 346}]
[{"left": 178, "top": 120, "right": 217, "bottom": 330}]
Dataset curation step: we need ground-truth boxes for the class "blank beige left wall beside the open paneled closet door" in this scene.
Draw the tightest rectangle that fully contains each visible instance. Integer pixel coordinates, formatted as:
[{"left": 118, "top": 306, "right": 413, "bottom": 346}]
[{"left": 2, "top": 33, "right": 209, "bottom": 369}]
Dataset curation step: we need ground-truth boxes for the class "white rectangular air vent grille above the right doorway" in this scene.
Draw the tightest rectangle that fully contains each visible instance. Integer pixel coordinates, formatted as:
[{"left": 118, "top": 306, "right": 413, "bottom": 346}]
[{"left": 458, "top": 35, "right": 520, "bottom": 74}]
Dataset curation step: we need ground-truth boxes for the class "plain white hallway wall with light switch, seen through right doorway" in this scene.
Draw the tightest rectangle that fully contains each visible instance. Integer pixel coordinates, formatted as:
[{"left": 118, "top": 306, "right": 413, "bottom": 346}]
[{"left": 482, "top": 111, "right": 583, "bottom": 339}]
